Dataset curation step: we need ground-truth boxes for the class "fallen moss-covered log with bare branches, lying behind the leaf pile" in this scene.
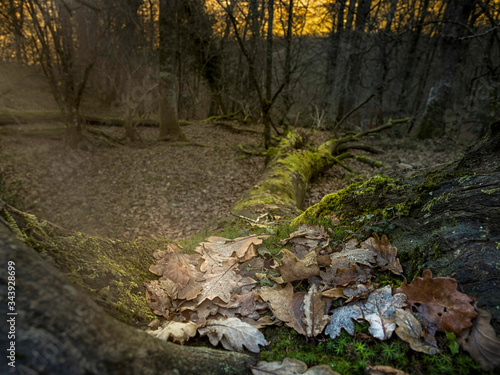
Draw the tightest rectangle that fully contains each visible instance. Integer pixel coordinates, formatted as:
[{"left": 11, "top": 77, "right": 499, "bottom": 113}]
[{"left": 232, "top": 119, "right": 407, "bottom": 220}]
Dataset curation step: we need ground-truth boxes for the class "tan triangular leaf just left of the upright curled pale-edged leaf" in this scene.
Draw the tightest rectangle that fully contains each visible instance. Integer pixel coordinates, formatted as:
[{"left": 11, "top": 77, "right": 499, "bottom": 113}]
[{"left": 257, "top": 283, "right": 306, "bottom": 335}]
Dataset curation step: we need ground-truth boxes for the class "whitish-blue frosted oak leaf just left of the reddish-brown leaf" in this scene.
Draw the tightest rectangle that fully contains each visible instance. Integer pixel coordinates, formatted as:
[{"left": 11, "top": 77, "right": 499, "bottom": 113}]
[{"left": 355, "top": 285, "right": 406, "bottom": 340}]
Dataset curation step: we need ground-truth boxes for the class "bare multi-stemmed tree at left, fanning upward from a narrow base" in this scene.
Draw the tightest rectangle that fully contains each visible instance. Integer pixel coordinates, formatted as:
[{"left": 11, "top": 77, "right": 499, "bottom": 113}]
[{"left": 25, "top": 0, "right": 107, "bottom": 147}]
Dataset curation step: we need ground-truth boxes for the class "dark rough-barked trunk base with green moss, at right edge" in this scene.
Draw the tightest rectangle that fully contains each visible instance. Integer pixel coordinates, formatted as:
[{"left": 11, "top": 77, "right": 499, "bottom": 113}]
[{"left": 293, "top": 123, "right": 500, "bottom": 333}]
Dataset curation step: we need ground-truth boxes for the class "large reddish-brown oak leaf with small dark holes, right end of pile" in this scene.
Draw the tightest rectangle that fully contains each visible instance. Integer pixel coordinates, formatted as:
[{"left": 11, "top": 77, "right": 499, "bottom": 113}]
[{"left": 396, "top": 270, "right": 477, "bottom": 337}]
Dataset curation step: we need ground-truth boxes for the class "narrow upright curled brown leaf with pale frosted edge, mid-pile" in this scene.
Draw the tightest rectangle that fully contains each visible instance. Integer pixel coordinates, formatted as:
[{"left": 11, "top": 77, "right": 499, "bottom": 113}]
[{"left": 302, "top": 284, "right": 329, "bottom": 337}]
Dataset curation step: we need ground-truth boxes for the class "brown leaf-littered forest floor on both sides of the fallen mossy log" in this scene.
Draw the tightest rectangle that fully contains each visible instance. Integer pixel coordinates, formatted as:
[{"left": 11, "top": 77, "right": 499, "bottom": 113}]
[{"left": 0, "top": 121, "right": 464, "bottom": 240}]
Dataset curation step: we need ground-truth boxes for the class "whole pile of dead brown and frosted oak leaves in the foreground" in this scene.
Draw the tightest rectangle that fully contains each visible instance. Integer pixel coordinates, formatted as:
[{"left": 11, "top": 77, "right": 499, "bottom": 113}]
[{"left": 146, "top": 225, "right": 500, "bottom": 369}]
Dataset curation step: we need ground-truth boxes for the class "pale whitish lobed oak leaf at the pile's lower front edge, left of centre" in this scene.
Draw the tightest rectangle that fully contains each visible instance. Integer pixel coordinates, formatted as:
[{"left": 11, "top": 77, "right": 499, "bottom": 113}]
[{"left": 198, "top": 318, "right": 267, "bottom": 353}]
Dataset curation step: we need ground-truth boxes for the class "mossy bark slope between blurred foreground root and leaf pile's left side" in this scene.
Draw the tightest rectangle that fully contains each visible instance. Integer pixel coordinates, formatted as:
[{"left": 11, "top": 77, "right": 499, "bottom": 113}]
[{"left": 0, "top": 200, "right": 169, "bottom": 325}]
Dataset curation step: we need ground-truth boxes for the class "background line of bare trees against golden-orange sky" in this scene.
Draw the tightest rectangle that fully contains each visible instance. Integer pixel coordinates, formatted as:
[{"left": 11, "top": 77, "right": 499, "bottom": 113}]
[{"left": 0, "top": 0, "right": 500, "bottom": 143}]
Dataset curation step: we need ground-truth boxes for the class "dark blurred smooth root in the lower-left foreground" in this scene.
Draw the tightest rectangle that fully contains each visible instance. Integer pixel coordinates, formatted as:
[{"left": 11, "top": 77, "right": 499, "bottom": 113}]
[{"left": 0, "top": 223, "right": 256, "bottom": 375}]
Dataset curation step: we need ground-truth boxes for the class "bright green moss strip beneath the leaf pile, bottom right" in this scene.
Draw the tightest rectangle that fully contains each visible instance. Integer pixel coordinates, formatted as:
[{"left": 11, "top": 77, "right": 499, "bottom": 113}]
[{"left": 260, "top": 323, "right": 493, "bottom": 375}]
